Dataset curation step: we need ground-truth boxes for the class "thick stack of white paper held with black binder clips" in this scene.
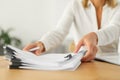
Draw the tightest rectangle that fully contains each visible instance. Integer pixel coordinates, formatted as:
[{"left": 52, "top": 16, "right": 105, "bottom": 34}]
[{"left": 6, "top": 46, "right": 83, "bottom": 70}]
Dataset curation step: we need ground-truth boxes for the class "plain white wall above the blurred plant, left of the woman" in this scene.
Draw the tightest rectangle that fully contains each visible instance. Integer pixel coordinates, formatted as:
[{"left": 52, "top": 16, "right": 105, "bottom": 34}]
[{"left": 0, "top": 0, "right": 70, "bottom": 45}]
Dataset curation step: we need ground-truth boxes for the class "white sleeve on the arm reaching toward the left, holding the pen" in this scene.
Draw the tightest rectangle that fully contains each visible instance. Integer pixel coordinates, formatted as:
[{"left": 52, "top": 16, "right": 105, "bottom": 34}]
[{"left": 39, "top": 2, "right": 74, "bottom": 51}]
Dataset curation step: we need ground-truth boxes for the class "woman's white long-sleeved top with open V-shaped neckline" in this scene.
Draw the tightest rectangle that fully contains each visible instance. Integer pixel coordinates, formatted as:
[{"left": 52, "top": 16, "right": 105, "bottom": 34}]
[{"left": 40, "top": 0, "right": 120, "bottom": 51}]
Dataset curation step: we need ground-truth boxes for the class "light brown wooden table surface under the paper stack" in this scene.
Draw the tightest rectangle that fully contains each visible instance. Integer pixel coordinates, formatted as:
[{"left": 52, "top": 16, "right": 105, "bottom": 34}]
[{"left": 0, "top": 57, "right": 120, "bottom": 80}]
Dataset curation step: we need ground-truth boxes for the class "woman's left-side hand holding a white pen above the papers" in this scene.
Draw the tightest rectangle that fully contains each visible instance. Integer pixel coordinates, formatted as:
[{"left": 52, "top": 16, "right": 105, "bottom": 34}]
[{"left": 23, "top": 42, "right": 45, "bottom": 55}]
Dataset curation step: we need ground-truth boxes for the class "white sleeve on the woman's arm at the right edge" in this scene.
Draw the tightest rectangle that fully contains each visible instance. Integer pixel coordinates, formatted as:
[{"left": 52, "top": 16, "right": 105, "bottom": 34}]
[{"left": 96, "top": 7, "right": 120, "bottom": 46}]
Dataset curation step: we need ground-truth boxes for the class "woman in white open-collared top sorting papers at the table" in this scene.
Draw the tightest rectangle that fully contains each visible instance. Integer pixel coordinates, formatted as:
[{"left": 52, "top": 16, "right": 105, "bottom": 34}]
[{"left": 23, "top": 0, "right": 120, "bottom": 61}]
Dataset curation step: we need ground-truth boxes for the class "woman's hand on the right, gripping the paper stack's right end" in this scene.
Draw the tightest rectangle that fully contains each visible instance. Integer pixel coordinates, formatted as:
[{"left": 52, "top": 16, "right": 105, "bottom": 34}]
[{"left": 74, "top": 32, "right": 98, "bottom": 61}]
